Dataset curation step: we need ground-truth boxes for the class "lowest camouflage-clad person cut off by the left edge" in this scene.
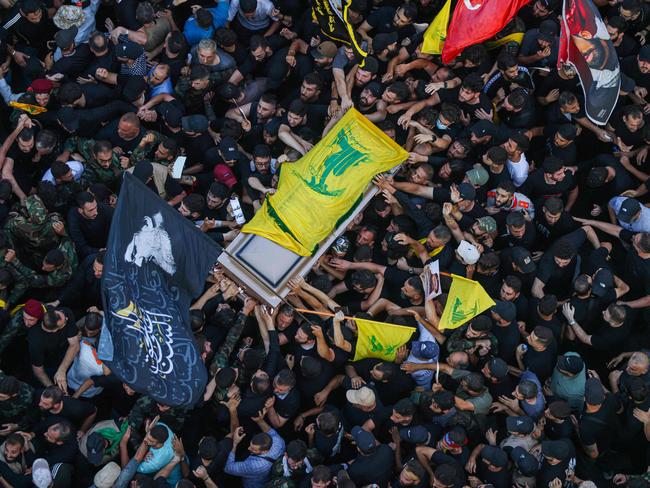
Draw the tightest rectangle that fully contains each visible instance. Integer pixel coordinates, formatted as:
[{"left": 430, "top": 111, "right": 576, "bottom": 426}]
[{"left": 0, "top": 371, "right": 39, "bottom": 438}]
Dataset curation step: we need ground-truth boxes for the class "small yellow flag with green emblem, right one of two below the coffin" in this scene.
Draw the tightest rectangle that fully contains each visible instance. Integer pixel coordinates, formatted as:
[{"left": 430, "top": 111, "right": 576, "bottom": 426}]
[{"left": 438, "top": 274, "right": 494, "bottom": 330}]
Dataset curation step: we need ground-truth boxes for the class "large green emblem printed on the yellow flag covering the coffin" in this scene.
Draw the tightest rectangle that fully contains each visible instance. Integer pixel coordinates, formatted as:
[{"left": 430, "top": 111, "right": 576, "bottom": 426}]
[{"left": 294, "top": 129, "right": 369, "bottom": 197}]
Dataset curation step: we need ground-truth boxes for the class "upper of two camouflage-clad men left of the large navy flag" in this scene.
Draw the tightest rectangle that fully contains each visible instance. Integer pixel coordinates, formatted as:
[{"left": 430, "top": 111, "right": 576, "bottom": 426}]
[{"left": 5, "top": 195, "right": 65, "bottom": 268}]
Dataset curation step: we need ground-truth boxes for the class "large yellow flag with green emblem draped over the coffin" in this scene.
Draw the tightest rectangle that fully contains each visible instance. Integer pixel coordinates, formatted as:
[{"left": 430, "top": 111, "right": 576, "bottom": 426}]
[{"left": 242, "top": 109, "right": 408, "bottom": 256}]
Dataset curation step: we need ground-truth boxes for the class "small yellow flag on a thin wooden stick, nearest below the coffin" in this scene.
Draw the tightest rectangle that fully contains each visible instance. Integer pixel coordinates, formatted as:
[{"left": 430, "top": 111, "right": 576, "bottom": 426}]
[{"left": 353, "top": 319, "right": 415, "bottom": 361}]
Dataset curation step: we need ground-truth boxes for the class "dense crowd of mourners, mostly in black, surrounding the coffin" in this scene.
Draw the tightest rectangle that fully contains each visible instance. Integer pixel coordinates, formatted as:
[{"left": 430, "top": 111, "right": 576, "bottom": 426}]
[{"left": 0, "top": 0, "right": 650, "bottom": 488}]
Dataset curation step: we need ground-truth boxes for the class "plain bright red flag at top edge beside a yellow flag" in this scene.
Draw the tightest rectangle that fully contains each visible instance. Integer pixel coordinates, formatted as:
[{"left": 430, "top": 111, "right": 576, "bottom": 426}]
[{"left": 442, "top": 0, "right": 530, "bottom": 63}]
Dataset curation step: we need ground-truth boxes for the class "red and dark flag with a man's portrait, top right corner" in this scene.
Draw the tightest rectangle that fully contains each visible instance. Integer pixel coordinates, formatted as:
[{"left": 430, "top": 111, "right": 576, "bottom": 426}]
[{"left": 557, "top": 0, "right": 621, "bottom": 125}]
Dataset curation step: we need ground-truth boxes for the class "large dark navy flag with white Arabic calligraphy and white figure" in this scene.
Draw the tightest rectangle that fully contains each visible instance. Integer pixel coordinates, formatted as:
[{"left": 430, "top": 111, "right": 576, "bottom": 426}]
[{"left": 99, "top": 173, "right": 220, "bottom": 406}]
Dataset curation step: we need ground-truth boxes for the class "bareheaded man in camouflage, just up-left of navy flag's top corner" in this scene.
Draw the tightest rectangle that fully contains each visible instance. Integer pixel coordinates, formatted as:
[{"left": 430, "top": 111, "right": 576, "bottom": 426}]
[{"left": 64, "top": 137, "right": 124, "bottom": 192}]
